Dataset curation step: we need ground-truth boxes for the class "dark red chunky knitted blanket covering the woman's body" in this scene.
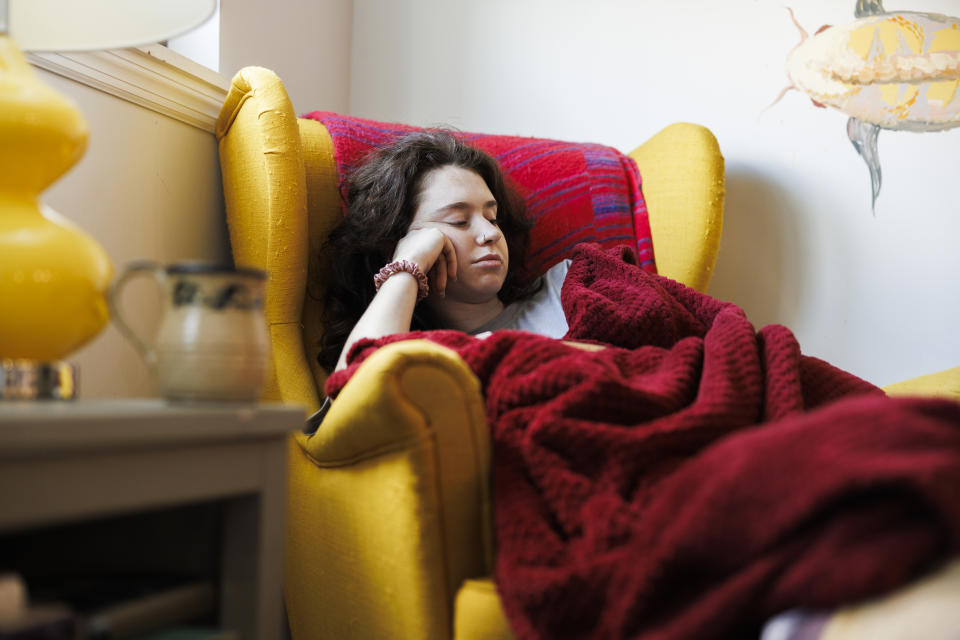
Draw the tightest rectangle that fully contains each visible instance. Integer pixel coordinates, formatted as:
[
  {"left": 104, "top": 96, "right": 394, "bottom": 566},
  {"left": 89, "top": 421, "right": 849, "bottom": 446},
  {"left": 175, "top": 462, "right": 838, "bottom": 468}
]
[{"left": 328, "top": 246, "right": 960, "bottom": 639}]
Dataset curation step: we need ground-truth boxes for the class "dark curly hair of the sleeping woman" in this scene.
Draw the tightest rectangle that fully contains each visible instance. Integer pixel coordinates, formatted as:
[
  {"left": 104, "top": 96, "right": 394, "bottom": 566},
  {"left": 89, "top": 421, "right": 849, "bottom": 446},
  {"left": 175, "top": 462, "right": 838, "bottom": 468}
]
[{"left": 317, "top": 129, "right": 540, "bottom": 371}]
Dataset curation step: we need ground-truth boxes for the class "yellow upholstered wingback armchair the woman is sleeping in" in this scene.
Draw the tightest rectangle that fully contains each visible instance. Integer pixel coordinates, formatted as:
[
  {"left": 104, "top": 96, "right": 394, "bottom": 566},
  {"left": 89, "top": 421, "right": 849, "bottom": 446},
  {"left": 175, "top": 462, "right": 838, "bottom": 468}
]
[{"left": 217, "top": 67, "right": 960, "bottom": 640}]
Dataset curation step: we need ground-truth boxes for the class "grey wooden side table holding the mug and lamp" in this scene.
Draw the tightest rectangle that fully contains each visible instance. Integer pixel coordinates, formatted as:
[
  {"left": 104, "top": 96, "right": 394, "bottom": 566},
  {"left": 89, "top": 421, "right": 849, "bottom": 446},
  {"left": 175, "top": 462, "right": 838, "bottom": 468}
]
[{"left": 0, "top": 399, "right": 304, "bottom": 640}]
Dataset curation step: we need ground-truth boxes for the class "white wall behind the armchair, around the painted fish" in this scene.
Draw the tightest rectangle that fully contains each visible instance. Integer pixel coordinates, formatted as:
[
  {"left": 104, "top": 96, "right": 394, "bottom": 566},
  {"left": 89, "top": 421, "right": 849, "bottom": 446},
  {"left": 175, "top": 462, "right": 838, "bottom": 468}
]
[{"left": 349, "top": 0, "right": 960, "bottom": 384}]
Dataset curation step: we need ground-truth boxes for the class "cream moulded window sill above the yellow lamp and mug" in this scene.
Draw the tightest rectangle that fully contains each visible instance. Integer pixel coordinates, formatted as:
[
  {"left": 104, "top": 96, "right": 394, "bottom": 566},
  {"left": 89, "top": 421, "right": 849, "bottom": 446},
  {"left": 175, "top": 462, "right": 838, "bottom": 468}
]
[{"left": 27, "top": 44, "right": 230, "bottom": 133}]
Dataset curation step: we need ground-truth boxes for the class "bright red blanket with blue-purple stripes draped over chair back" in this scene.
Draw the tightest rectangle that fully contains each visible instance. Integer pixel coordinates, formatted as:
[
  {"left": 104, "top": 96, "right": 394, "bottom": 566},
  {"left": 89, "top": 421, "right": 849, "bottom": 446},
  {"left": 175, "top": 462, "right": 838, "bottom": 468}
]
[{"left": 304, "top": 111, "right": 656, "bottom": 273}]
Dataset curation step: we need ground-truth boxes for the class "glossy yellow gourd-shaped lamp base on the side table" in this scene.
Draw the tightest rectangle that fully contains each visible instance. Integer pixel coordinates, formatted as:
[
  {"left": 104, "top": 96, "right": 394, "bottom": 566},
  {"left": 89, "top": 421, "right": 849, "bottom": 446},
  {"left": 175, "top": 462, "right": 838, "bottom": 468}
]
[{"left": 0, "top": 36, "right": 113, "bottom": 361}]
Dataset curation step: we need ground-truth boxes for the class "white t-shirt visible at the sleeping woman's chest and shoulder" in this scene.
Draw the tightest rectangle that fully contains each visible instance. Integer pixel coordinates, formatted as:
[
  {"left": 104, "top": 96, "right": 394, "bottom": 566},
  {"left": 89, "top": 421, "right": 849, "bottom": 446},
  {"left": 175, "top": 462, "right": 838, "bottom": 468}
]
[{"left": 470, "top": 260, "right": 570, "bottom": 338}]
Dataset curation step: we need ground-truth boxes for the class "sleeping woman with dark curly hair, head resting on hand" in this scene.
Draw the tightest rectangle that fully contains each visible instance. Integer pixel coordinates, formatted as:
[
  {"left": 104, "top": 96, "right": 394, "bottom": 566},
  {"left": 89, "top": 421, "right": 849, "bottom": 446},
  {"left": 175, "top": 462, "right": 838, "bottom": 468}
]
[{"left": 319, "top": 130, "right": 569, "bottom": 370}]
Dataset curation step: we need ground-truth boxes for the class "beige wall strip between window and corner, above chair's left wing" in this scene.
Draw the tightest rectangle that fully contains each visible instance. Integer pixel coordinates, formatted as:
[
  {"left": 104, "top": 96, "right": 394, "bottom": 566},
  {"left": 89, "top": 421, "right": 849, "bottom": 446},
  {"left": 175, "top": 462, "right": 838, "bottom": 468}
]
[{"left": 220, "top": 0, "right": 353, "bottom": 114}]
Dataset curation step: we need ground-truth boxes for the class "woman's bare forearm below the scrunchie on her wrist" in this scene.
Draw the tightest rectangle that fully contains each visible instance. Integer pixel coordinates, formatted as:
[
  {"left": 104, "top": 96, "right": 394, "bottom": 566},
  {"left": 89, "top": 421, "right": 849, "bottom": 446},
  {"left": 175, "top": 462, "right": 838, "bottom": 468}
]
[{"left": 336, "top": 272, "right": 418, "bottom": 371}]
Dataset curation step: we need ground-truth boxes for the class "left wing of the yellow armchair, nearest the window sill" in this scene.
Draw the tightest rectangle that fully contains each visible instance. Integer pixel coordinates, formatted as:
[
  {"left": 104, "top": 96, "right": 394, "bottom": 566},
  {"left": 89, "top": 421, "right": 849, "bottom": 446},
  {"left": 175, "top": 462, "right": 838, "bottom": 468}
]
[{"left": 216, "top": 67, "right": 319, "bottom": 411}]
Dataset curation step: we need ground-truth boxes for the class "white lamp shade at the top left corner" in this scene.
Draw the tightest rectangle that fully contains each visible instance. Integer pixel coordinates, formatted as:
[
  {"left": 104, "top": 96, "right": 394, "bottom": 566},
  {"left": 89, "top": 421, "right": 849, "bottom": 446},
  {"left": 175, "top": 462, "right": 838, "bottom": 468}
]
[{"left": 6, "top": 0, "right": 217, "bottom": 51}]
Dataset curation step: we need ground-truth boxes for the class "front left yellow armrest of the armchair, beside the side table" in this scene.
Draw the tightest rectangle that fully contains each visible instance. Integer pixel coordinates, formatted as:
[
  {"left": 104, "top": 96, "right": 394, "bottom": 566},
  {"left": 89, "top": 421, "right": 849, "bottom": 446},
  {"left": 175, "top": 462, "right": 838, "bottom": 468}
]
[{"left": 286, "top": 340, "right": 492, "bottom": 639}]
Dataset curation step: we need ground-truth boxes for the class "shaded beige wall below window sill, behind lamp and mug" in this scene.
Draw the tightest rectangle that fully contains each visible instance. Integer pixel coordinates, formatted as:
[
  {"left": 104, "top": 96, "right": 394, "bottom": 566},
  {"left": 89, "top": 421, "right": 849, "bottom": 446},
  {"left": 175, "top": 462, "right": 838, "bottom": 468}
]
[{"left": 38, "top": 71, "right": 230, "bottom": 398}]
